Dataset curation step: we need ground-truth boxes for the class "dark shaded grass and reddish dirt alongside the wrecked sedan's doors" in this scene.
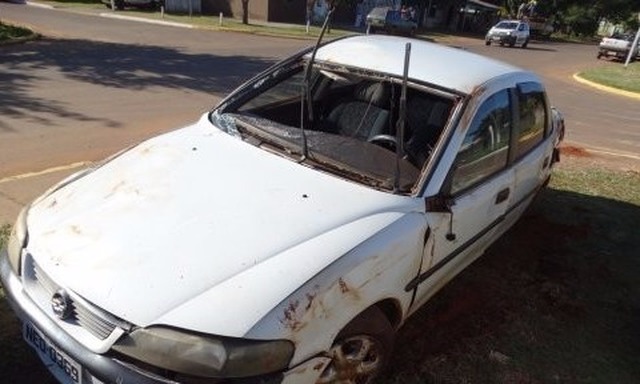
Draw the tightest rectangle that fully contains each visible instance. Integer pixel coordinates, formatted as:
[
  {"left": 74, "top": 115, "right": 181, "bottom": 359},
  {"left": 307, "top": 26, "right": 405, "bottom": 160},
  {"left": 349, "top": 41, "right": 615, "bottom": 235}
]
[{"left": 380, "top": 185, "right": 640, "bottom": 384}]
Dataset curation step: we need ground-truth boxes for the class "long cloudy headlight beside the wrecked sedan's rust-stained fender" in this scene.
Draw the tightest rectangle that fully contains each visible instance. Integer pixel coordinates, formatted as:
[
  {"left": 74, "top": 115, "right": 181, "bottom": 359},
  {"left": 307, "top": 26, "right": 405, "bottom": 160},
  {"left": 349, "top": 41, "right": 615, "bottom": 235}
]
[{"left": 113, "top": 327, "right": 294, "bottom": 377}]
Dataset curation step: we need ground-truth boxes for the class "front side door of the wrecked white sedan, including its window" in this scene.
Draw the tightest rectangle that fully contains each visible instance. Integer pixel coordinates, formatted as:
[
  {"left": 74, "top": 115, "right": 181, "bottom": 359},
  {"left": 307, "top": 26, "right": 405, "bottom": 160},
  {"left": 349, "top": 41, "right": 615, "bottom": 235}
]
[{"left": 407, "top": 89, "right": 514, "bottom": 308}]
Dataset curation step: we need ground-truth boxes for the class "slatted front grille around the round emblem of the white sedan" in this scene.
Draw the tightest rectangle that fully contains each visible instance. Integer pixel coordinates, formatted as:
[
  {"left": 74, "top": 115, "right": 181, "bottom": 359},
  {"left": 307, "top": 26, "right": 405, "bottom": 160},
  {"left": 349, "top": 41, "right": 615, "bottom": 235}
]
[{"left": 24, "top": 254, "right": 129, "bottom": 340}]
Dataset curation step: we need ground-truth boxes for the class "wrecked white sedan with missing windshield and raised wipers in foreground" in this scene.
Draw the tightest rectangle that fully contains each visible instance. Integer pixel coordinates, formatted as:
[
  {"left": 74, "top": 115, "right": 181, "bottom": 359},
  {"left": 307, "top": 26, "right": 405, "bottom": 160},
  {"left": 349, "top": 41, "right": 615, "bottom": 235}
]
[{"left": 0, "top": 35, "right": 564, "bottom": 384}]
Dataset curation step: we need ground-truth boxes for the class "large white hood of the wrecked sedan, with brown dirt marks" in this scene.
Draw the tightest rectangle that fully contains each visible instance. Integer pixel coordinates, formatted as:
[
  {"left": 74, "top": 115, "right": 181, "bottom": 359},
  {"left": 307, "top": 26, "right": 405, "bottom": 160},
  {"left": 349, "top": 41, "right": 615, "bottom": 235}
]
[{"left": 28, "top": 113, "right": 422, "bottom": 336}]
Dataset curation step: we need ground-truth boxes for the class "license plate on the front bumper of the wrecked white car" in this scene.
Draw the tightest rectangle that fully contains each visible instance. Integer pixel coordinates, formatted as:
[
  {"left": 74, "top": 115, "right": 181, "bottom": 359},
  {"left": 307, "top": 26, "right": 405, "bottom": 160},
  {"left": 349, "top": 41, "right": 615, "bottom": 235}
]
[{"left": 23, "top": 322, "right": 82, "bottom": 384}]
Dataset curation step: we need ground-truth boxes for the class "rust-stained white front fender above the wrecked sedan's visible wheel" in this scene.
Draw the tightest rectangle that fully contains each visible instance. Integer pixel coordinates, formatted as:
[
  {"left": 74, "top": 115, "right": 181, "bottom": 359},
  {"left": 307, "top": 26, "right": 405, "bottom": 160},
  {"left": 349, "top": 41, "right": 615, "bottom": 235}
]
[{"left": 247, "top": 212, "right": 427, "bottom": 366}]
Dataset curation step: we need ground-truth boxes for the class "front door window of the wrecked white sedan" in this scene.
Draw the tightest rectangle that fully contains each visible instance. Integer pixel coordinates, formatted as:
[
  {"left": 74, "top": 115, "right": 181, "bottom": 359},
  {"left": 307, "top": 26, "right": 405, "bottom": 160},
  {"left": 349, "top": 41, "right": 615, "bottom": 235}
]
[{"left": 451, "top": 89, "right": 512, "bottom": 195}]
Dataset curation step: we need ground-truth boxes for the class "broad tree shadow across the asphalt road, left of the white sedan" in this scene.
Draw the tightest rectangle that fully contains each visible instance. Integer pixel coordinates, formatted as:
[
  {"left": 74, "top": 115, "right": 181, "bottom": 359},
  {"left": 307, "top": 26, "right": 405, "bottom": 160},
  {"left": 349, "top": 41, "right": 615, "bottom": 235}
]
[{"left": 0, "top": 39, "right": 274, "bottom": 131}]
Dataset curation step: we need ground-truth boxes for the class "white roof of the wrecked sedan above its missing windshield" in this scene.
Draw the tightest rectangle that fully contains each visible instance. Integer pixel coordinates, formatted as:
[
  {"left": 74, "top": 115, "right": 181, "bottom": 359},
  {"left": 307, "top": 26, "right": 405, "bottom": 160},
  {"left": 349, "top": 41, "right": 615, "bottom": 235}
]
[{"left": 316, "top": 35, "right": 523, "bottom": 94}]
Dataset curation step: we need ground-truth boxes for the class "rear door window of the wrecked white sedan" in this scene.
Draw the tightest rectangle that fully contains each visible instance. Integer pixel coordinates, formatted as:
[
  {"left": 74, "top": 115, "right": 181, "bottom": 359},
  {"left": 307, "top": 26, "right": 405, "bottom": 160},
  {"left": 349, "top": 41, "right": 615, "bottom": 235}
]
[{"left": 515, "top": 83, "right": 547, "bottom": 158}]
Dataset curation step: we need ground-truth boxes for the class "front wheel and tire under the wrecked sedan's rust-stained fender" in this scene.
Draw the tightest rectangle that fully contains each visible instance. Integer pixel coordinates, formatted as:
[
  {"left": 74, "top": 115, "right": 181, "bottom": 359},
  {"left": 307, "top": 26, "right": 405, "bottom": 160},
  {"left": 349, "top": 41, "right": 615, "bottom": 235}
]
[{"left": 316, "top": 307, "right": 394, "bottom": 384}]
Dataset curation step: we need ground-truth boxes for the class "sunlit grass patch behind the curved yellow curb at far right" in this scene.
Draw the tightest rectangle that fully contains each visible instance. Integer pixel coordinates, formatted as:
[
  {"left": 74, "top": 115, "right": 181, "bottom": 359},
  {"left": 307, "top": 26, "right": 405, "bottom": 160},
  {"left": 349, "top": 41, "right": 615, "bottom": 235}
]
[{"left": 578, "top": 61, "right": 640, "bottom": 94}]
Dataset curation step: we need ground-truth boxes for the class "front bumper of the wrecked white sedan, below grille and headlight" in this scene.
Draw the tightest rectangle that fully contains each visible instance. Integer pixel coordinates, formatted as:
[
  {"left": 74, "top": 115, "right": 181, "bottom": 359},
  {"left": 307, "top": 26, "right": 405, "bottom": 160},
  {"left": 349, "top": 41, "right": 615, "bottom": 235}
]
[{"left": 0, "top": 250, "right": 330, "bottom": 384}]
